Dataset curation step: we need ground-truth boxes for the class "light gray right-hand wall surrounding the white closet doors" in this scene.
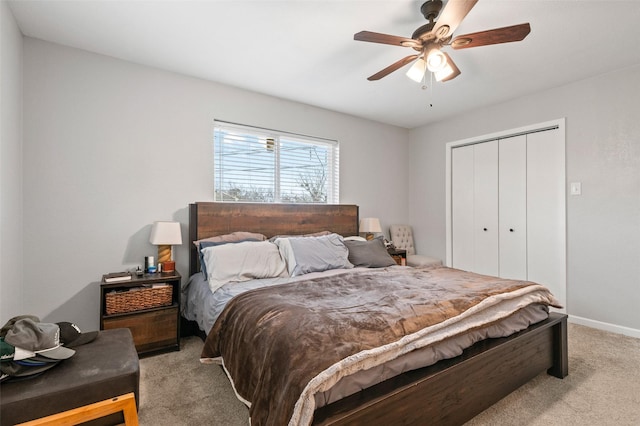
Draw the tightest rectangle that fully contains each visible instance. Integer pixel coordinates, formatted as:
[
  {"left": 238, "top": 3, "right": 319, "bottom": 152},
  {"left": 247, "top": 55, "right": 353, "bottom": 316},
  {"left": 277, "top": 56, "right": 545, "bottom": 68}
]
[{"left": 409, "top": 66, "right": 640, "bottom": 336}]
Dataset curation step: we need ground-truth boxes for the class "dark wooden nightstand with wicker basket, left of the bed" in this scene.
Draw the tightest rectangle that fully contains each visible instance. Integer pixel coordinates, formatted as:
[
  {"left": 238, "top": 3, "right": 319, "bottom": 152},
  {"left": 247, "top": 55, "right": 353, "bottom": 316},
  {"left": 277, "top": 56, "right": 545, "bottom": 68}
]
[{"left": 100, "top": 272, "right": 182, "bottom": 355}]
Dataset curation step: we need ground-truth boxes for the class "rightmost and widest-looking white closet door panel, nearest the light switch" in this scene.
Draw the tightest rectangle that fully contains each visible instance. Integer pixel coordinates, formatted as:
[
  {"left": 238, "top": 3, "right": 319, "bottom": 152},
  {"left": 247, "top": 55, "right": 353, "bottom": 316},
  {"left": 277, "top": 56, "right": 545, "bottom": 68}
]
[{"left": 527, "top": 129, "right": 566, "bottom": 304}]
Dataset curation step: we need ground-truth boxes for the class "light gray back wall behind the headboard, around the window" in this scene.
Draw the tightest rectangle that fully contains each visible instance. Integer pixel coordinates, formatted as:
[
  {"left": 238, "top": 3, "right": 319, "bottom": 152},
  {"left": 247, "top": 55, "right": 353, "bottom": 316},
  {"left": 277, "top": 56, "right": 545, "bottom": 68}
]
[{"left": 24, "top": 38, "right": 408, "bottom": 330}]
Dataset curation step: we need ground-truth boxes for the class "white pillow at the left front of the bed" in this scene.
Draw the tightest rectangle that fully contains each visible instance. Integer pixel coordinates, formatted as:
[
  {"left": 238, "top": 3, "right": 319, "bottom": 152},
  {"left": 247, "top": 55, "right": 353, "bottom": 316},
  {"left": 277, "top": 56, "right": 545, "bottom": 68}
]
[{"left": 202, "top": 241, "right": 287, "bottom": 292}]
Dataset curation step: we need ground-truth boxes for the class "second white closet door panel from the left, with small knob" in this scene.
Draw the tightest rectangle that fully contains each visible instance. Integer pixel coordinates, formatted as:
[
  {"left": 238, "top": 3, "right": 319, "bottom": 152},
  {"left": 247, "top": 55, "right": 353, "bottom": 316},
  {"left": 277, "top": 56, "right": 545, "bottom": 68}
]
[{"left": 473, "top": 141, "right": 500, "bottom": 276}]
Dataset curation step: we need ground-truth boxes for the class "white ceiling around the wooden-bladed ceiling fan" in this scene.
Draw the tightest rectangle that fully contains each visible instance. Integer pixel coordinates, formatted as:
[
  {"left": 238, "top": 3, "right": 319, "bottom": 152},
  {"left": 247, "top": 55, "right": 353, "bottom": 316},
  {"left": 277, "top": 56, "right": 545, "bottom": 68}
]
[{"left": 9, "top": 0, "right": 640, "bottom": 128}]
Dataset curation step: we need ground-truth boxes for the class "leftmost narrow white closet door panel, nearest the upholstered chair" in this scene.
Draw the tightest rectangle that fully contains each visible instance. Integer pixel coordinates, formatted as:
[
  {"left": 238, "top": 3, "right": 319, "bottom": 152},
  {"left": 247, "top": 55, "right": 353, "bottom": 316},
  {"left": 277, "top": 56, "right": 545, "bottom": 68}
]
[{"left": 451, "top": 145, "right": 474, "bottom": 271}]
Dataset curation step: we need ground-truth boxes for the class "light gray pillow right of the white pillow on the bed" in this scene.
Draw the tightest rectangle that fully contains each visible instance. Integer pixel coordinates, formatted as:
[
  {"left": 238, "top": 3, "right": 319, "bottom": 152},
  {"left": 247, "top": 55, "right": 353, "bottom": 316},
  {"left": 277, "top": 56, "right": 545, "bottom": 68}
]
[{"left": 275, "top": 234, "right": 353, "bottom": 277}]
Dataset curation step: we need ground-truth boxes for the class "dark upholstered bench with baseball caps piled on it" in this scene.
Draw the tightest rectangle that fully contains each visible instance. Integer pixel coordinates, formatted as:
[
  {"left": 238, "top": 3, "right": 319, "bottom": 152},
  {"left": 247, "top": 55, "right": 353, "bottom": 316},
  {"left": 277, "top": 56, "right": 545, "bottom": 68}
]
[{"left": 0, "top": 328, "right": 140, "bottom": 426}]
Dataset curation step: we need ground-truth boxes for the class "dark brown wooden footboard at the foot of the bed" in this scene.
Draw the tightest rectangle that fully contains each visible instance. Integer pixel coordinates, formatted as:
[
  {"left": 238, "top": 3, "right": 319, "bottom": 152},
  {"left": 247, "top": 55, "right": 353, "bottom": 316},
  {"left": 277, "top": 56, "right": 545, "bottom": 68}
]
[{"left": 313, "top": 313, "right": 568, "bottom": 426}]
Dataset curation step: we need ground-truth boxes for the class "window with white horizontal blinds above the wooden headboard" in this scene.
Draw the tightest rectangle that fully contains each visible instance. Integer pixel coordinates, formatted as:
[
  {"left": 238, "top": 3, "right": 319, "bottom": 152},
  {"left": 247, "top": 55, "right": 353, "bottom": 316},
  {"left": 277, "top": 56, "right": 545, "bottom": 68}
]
[{"left": 213, "top": 121, "right": 339, "bottom": 204}]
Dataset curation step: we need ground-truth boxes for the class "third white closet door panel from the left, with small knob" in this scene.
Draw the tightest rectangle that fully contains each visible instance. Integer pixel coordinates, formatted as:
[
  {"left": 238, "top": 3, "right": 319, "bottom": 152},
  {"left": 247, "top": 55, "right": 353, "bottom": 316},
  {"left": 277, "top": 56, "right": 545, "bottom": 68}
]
[{"left": 498, "top": 135, "right": 527, "bottom": 280}]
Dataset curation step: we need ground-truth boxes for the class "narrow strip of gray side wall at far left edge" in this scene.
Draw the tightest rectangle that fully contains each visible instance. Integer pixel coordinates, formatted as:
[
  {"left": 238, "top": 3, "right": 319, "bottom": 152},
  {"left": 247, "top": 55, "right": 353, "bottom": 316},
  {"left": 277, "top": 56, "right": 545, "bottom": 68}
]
[{"left": 0, "top": 1, "right": 23, "bottom": 324}]
